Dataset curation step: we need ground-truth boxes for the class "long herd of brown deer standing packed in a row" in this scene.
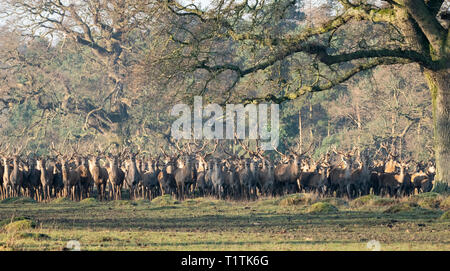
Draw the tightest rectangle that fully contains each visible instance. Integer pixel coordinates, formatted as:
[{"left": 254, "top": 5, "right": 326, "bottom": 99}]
[{"left": 0, "top": 140, "right": 435, "bottom": 201}]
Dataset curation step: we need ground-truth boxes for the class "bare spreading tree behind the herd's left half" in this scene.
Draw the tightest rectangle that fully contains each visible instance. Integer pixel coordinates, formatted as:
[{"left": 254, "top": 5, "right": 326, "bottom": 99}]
[{"left": 2, "top": 0, "right": 164, "bottom": 143}]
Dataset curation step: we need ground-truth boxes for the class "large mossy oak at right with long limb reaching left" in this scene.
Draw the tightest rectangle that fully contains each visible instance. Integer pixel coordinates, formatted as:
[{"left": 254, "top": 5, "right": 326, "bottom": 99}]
[{"left": 154, "top": 0, "right": 450, "bottom": 189}]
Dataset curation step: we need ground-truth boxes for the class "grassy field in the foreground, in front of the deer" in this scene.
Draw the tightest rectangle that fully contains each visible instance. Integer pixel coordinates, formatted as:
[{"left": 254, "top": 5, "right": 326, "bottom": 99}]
[{"left": 0, "top": 193, "right": 450, "bottom": 250}]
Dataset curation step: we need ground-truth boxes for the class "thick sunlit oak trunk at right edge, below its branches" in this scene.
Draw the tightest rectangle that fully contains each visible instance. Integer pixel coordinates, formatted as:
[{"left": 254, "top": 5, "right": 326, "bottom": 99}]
[{"left": 425, "top": 69, "right": 450, "bottom": 192}]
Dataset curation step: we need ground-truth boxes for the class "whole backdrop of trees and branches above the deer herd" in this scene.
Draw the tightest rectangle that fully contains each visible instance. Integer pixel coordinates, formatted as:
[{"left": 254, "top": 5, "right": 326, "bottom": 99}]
[{"left": 0, "top": 0, "right": 450, "bottom": 188}]
